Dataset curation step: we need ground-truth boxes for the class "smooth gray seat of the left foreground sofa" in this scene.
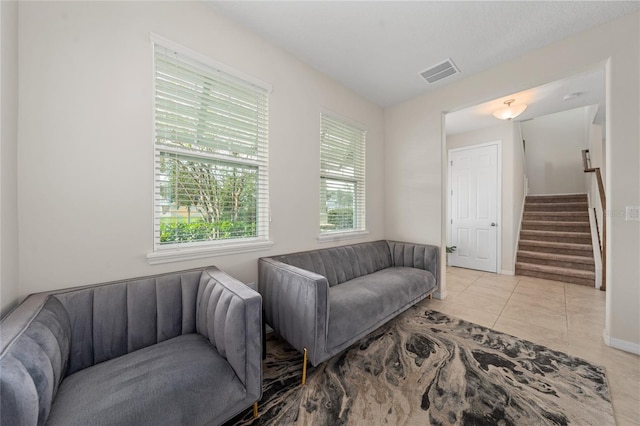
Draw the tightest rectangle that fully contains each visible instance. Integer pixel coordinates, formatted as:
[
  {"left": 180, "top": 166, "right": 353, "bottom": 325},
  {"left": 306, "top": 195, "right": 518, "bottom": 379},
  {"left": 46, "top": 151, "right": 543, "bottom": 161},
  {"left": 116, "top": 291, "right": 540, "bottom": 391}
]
[{"left": 47, "top": 334, "right": 245, "bottom": 425}]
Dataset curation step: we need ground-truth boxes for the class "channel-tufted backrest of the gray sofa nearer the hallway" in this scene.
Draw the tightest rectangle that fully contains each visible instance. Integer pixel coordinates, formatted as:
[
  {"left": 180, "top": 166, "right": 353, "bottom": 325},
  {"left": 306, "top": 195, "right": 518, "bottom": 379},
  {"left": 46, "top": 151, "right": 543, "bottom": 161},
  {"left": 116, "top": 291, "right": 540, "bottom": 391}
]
[{"left": 273, "top": 241, "right": 391, "bottom": 287}]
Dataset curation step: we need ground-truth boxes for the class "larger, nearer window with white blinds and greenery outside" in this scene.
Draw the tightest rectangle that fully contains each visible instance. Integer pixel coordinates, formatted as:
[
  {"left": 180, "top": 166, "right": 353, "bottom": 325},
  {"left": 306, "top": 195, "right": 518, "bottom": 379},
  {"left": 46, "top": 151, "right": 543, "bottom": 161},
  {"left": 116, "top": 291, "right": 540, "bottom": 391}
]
[{"left": 154, "top": 37, "right": 269, "bottom": 251}]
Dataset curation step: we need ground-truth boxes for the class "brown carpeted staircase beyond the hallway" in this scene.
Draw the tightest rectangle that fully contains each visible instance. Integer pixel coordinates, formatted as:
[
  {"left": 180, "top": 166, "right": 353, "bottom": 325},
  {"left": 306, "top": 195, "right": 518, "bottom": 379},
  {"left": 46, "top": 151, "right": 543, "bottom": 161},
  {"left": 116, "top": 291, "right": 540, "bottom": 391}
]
[{"left": 516, "top": 194, "right": 595, "bottom": 287}]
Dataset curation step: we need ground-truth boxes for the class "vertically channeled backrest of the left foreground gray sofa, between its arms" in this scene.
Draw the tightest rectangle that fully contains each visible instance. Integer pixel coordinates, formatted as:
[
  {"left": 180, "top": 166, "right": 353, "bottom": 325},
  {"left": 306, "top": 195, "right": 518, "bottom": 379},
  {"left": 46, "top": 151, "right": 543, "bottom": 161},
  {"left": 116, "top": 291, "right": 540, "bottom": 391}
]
[{"left": 54, "top": 270, "right": 202, "bottom": 374}]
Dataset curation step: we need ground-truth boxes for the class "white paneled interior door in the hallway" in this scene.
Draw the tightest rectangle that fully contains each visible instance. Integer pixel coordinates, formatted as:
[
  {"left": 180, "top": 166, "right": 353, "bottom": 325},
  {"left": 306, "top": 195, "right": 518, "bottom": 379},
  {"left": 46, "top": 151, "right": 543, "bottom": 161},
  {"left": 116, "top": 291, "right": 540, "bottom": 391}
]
[{"left": 449, "top": 144, "right": 499, "bottom": 273}]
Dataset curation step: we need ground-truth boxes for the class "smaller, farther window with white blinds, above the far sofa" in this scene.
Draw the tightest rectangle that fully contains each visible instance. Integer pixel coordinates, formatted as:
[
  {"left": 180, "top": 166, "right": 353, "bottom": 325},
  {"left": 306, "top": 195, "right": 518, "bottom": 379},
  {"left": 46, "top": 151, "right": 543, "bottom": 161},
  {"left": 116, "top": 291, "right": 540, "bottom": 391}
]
[{"left": 320, "top": 113, "right": 367, "bottom": 235}]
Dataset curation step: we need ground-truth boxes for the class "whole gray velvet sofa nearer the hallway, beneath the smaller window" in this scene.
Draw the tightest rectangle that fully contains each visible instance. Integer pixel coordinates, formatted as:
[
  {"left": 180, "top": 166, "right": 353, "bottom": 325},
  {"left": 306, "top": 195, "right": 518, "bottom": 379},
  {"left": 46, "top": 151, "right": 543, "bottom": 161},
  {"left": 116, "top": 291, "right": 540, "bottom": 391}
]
[{"left": 258, "top": 241, "right": 440, "bottom": 366}]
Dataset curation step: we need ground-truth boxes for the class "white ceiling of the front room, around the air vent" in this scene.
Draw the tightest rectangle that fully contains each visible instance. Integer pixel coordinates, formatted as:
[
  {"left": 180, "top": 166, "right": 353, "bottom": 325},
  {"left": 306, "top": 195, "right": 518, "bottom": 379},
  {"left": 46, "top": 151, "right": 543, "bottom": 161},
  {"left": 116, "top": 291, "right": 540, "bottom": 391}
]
[{"left": 209, "top": 1, "right": 640, "bottom": 107}]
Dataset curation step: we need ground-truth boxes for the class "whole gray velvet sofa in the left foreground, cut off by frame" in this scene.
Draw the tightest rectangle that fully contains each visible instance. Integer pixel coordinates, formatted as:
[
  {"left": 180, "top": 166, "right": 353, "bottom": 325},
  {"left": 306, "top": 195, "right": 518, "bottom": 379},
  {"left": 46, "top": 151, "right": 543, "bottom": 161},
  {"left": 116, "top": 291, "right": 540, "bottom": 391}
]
[{"left": 0, "top": 267, "right": 262, "bottom": 426}]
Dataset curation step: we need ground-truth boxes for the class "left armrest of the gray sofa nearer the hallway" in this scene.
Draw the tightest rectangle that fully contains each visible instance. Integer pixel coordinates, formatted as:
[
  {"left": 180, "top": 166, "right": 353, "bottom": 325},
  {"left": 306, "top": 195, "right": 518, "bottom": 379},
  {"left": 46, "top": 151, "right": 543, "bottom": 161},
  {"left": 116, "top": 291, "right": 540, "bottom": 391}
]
[{"left": 258, "top": 258, "right": 329, "bottom": 365}]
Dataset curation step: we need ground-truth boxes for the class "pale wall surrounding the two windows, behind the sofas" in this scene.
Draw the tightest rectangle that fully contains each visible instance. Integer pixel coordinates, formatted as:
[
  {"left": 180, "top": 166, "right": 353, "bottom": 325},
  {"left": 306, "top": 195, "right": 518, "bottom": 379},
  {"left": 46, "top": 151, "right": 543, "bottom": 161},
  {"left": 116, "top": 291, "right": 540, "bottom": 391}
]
[{"left": 18, "top": 1, "right": 384, "bottom": 295}]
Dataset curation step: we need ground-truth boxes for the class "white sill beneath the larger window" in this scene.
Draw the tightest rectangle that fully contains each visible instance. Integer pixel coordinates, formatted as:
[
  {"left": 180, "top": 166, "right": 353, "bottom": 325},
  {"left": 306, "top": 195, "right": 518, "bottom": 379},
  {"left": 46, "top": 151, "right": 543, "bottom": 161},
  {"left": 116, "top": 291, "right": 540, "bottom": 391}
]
[{"left": 147, "top": 240, "right": 273, "bottom": 265}]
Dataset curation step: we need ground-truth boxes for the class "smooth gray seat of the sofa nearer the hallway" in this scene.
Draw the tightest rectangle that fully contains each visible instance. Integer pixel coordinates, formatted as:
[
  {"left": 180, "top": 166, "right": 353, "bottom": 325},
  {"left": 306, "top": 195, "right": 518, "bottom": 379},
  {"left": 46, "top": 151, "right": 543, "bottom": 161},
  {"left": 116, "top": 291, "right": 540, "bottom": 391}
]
[{"left": 327, "top": 267, "right": 436, "bottom": 351}]
